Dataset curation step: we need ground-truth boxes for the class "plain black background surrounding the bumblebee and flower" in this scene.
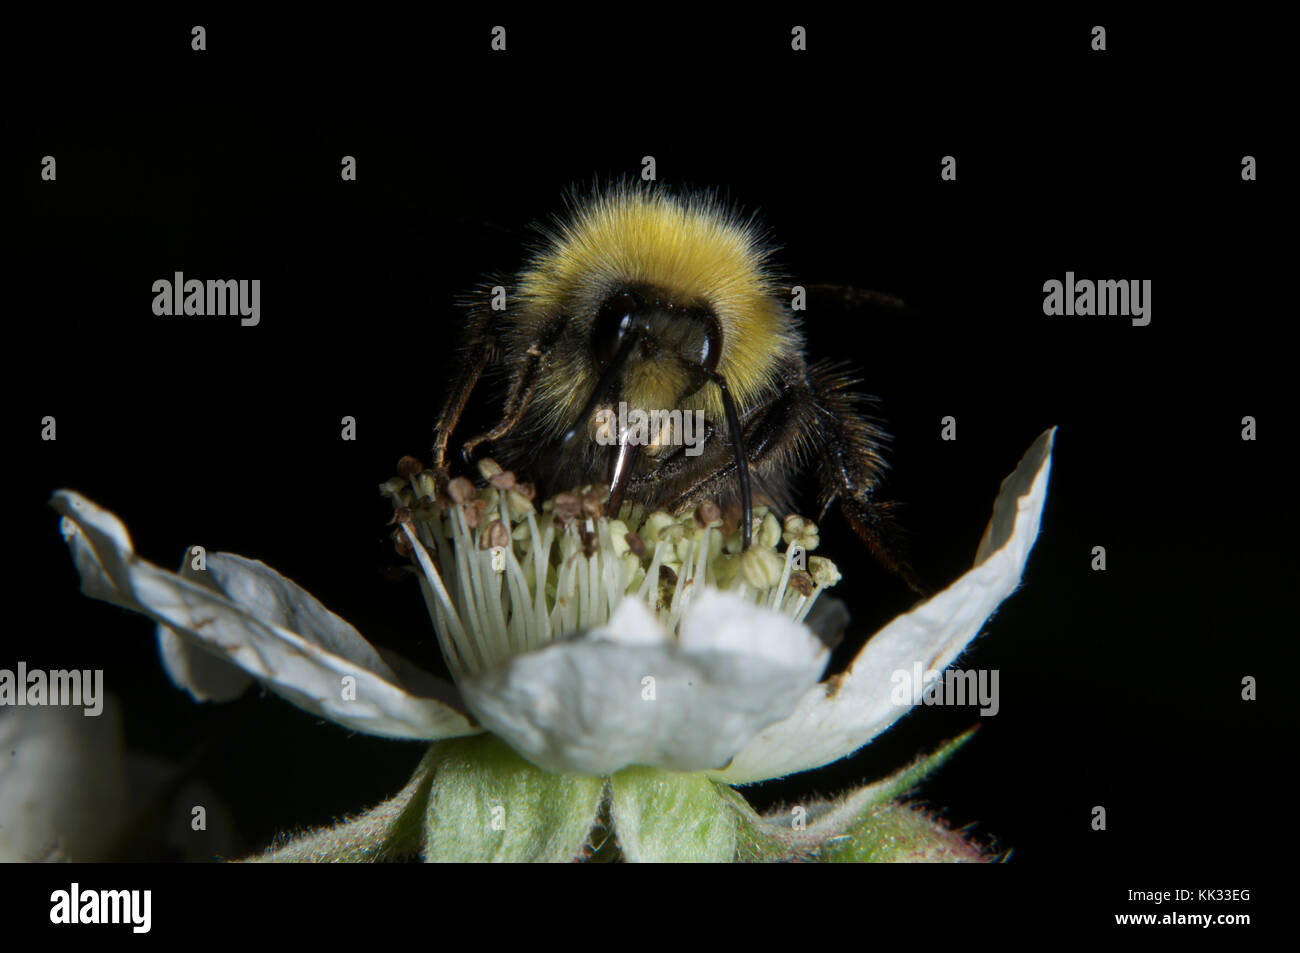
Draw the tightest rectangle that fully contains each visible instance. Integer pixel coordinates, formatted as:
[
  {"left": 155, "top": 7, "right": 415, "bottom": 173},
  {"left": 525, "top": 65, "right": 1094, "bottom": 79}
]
[{"left": 0, "top": 7, "right": 1296, "bottom": 904}]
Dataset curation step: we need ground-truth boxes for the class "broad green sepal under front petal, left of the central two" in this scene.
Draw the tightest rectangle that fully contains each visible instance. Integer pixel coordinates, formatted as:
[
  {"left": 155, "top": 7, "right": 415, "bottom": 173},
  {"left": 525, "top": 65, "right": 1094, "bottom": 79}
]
[{"left": 424, "top": 735, "right": 605, "bottom": 863}]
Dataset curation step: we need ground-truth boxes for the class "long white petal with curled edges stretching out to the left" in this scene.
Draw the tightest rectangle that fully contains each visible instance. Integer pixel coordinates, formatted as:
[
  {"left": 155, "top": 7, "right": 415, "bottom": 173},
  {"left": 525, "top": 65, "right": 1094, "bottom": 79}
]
[{"left": 51, "top": 490, "right": 480, "bottom": 738}]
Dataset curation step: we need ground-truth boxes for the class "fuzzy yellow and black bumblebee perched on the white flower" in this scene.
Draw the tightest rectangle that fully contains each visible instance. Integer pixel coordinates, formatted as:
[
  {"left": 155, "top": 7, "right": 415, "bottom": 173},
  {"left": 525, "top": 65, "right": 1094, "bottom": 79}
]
[{"left": 433, "top": 183, "right": 924, "bottom": 593}]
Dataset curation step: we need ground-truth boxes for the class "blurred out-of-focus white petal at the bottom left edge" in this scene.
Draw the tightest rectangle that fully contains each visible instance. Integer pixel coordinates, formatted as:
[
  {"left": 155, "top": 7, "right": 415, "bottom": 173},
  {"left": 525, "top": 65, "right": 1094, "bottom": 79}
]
[{"left": 0, "top": 697, "right": 127, "bottom": 862}]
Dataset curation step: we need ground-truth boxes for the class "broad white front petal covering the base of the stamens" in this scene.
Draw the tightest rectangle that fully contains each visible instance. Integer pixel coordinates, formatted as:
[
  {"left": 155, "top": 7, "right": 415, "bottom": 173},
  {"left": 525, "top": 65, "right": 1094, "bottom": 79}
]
[{"left": 460, "top": 589, "right": 827, "bottom": 775}]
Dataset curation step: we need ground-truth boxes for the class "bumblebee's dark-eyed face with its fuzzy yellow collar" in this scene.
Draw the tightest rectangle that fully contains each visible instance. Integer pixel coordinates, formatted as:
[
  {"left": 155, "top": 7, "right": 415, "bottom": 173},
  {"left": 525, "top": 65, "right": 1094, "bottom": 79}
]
[{"left": 517, "top": 185, "right": 801, "bottom": 439}]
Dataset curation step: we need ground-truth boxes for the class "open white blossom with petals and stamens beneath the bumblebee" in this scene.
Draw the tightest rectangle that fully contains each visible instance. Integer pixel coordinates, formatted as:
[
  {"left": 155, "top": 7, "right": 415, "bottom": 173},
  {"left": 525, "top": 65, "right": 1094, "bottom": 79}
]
[{"left": 52, "top": 430, "right": 1054, "bottom": 859}]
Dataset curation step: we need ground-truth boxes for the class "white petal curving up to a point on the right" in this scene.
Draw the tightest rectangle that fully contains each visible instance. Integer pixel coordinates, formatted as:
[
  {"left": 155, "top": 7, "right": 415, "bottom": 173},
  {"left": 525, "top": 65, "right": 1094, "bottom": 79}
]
[{"left": 714, "top": 428, "right": 1056, "bottom": 784}]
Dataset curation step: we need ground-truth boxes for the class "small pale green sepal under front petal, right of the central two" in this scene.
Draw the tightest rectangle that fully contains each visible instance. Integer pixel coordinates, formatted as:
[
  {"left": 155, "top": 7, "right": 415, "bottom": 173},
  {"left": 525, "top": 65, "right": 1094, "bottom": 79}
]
[{"left": 610, "top": 767, "right": 737, "bottom": 863}]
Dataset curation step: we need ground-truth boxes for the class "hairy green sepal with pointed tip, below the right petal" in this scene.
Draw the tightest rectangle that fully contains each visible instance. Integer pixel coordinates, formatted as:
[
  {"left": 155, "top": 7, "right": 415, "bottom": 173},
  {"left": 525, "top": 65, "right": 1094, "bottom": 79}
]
[{"left": 719, "top": 728, "right": 979, "bottom": 862}]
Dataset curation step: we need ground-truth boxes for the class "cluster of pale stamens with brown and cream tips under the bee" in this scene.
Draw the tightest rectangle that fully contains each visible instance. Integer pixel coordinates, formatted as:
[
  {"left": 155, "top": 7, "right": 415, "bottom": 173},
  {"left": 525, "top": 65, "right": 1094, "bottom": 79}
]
[{"left": 380, "top": 460, "right": 840, "bottom": 680}]
